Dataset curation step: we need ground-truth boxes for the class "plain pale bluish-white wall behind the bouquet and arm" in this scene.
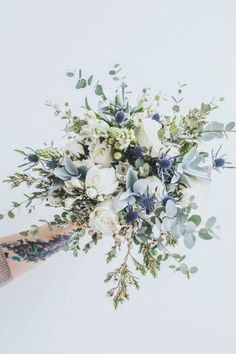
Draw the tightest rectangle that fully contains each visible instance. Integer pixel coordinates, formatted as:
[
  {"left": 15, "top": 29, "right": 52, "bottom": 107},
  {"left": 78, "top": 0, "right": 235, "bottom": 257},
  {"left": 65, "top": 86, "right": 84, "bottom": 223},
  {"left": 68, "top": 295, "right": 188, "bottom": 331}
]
[{"left": 0, "top": 0, "right": 236, "bottom": 354}]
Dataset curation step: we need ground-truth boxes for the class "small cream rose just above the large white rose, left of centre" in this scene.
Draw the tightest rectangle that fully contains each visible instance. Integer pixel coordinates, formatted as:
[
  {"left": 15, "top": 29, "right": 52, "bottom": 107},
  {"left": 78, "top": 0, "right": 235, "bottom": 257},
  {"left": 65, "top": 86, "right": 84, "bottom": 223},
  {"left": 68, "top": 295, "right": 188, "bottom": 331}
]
[{"left": 89, "top": 141, "right": 113, "bottom": 166}]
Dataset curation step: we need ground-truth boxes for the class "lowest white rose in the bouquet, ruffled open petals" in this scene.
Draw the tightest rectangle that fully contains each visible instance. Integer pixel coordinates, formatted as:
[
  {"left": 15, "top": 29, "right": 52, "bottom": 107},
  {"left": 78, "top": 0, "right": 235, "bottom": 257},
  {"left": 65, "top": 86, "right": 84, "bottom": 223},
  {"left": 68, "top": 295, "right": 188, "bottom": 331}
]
[{"left": 89, "top": 200, "right": 120, "bottom": 236}]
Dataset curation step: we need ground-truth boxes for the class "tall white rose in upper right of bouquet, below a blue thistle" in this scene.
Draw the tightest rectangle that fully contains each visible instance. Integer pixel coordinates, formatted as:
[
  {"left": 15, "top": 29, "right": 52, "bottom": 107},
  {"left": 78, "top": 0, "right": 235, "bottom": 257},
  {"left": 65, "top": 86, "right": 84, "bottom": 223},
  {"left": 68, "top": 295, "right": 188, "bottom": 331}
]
[{"left": 137, "top": 118, "right": 162, "bottom": 157}]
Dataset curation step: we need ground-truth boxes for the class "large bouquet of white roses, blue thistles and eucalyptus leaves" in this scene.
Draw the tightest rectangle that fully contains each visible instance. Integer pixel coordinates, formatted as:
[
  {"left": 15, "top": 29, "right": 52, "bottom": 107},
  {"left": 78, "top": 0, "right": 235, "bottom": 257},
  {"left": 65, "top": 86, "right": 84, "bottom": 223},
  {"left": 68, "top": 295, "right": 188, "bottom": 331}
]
[{"left": 0, "top": 64, "right": 235, "bottom": 307}]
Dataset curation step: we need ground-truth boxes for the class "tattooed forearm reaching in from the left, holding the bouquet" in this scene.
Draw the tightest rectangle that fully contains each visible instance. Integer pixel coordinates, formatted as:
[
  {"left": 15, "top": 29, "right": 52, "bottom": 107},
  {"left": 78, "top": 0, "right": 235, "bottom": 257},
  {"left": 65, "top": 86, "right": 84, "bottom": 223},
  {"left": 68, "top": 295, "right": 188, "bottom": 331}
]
[{"left": 0, "top": 225, "right": 75, "bottom": 287}]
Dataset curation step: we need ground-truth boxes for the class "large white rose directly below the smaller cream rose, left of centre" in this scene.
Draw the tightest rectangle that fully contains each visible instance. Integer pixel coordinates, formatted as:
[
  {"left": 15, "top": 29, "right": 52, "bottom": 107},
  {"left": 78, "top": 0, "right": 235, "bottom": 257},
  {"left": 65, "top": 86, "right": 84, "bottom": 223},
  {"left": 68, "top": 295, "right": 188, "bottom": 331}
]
[{"left": 85, "top": 166, "right": 118, "bottom": 198}]
